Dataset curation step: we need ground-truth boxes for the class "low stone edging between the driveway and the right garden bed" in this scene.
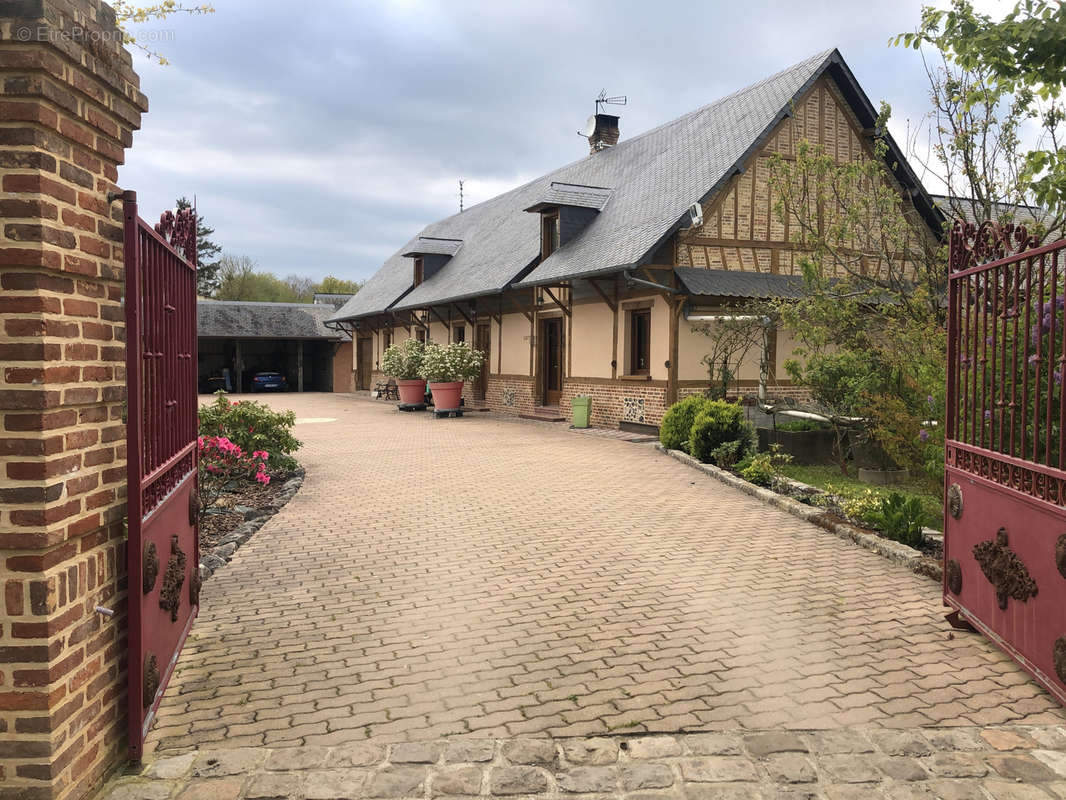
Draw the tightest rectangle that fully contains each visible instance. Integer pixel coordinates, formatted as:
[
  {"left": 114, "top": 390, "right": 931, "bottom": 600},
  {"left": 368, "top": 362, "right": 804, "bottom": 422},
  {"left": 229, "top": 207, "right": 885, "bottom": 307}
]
[{"left": 656, "top": 444, "right": 942, "bottom": 581}]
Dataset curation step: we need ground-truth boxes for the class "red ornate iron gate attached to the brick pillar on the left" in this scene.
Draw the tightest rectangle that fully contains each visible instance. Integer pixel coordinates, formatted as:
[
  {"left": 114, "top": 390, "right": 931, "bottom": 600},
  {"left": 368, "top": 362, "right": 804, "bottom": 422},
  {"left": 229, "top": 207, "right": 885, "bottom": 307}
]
[{"left": 123, "top": 192, "right": 199, "bottom": 759}]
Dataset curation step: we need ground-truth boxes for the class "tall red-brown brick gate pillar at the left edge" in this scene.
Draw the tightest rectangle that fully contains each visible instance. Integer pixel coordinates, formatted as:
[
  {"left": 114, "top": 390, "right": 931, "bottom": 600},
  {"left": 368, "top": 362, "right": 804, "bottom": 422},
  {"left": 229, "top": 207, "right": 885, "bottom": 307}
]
[{"left": 0, "top": 0, "right": 147, "bottom": 800}]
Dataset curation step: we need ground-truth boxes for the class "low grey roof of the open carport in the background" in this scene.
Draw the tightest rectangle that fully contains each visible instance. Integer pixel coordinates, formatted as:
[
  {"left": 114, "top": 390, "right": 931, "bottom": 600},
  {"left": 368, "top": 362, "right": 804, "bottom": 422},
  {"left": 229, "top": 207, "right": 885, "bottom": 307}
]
[{"left": 196, "top": 295, "right": 347, "bottom": 341}]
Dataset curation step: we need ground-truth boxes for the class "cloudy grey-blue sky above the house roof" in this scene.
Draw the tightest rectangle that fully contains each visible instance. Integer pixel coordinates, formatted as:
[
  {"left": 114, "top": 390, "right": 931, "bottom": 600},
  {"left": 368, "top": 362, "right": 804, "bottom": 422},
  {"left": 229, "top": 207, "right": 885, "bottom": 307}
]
[{"left": 119, "top": 0, "right": 997, "bottom": 279}]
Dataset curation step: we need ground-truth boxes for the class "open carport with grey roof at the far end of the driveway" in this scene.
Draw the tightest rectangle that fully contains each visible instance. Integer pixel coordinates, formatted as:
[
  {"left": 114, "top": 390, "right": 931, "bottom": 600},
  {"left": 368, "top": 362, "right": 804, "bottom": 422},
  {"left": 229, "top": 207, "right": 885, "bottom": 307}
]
[{"left": 196, "top": 300, "right": 352, "bottom": 393}]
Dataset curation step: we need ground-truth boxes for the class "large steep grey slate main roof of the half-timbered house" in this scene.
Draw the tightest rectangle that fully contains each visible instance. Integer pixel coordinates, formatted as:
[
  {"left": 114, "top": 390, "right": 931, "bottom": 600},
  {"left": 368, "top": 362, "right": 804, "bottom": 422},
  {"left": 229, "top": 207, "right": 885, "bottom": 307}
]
[{"left": 333, "top": 50, "right": 936, "bottom": 321}]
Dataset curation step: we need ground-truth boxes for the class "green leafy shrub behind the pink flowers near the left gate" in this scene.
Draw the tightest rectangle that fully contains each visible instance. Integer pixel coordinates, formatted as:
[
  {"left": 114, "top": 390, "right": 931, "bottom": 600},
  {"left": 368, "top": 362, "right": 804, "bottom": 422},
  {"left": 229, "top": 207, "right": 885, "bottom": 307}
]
[{"left": 199, "top": 391, "right": 301, "bottom": 473}]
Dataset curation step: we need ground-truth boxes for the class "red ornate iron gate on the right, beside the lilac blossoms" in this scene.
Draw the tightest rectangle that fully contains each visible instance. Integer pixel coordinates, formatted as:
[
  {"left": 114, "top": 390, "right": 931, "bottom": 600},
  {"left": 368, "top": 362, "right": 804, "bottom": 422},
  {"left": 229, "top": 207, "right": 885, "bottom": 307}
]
[{"left": 943, "top": 222, "right": 1066, "bottom": 703}]
